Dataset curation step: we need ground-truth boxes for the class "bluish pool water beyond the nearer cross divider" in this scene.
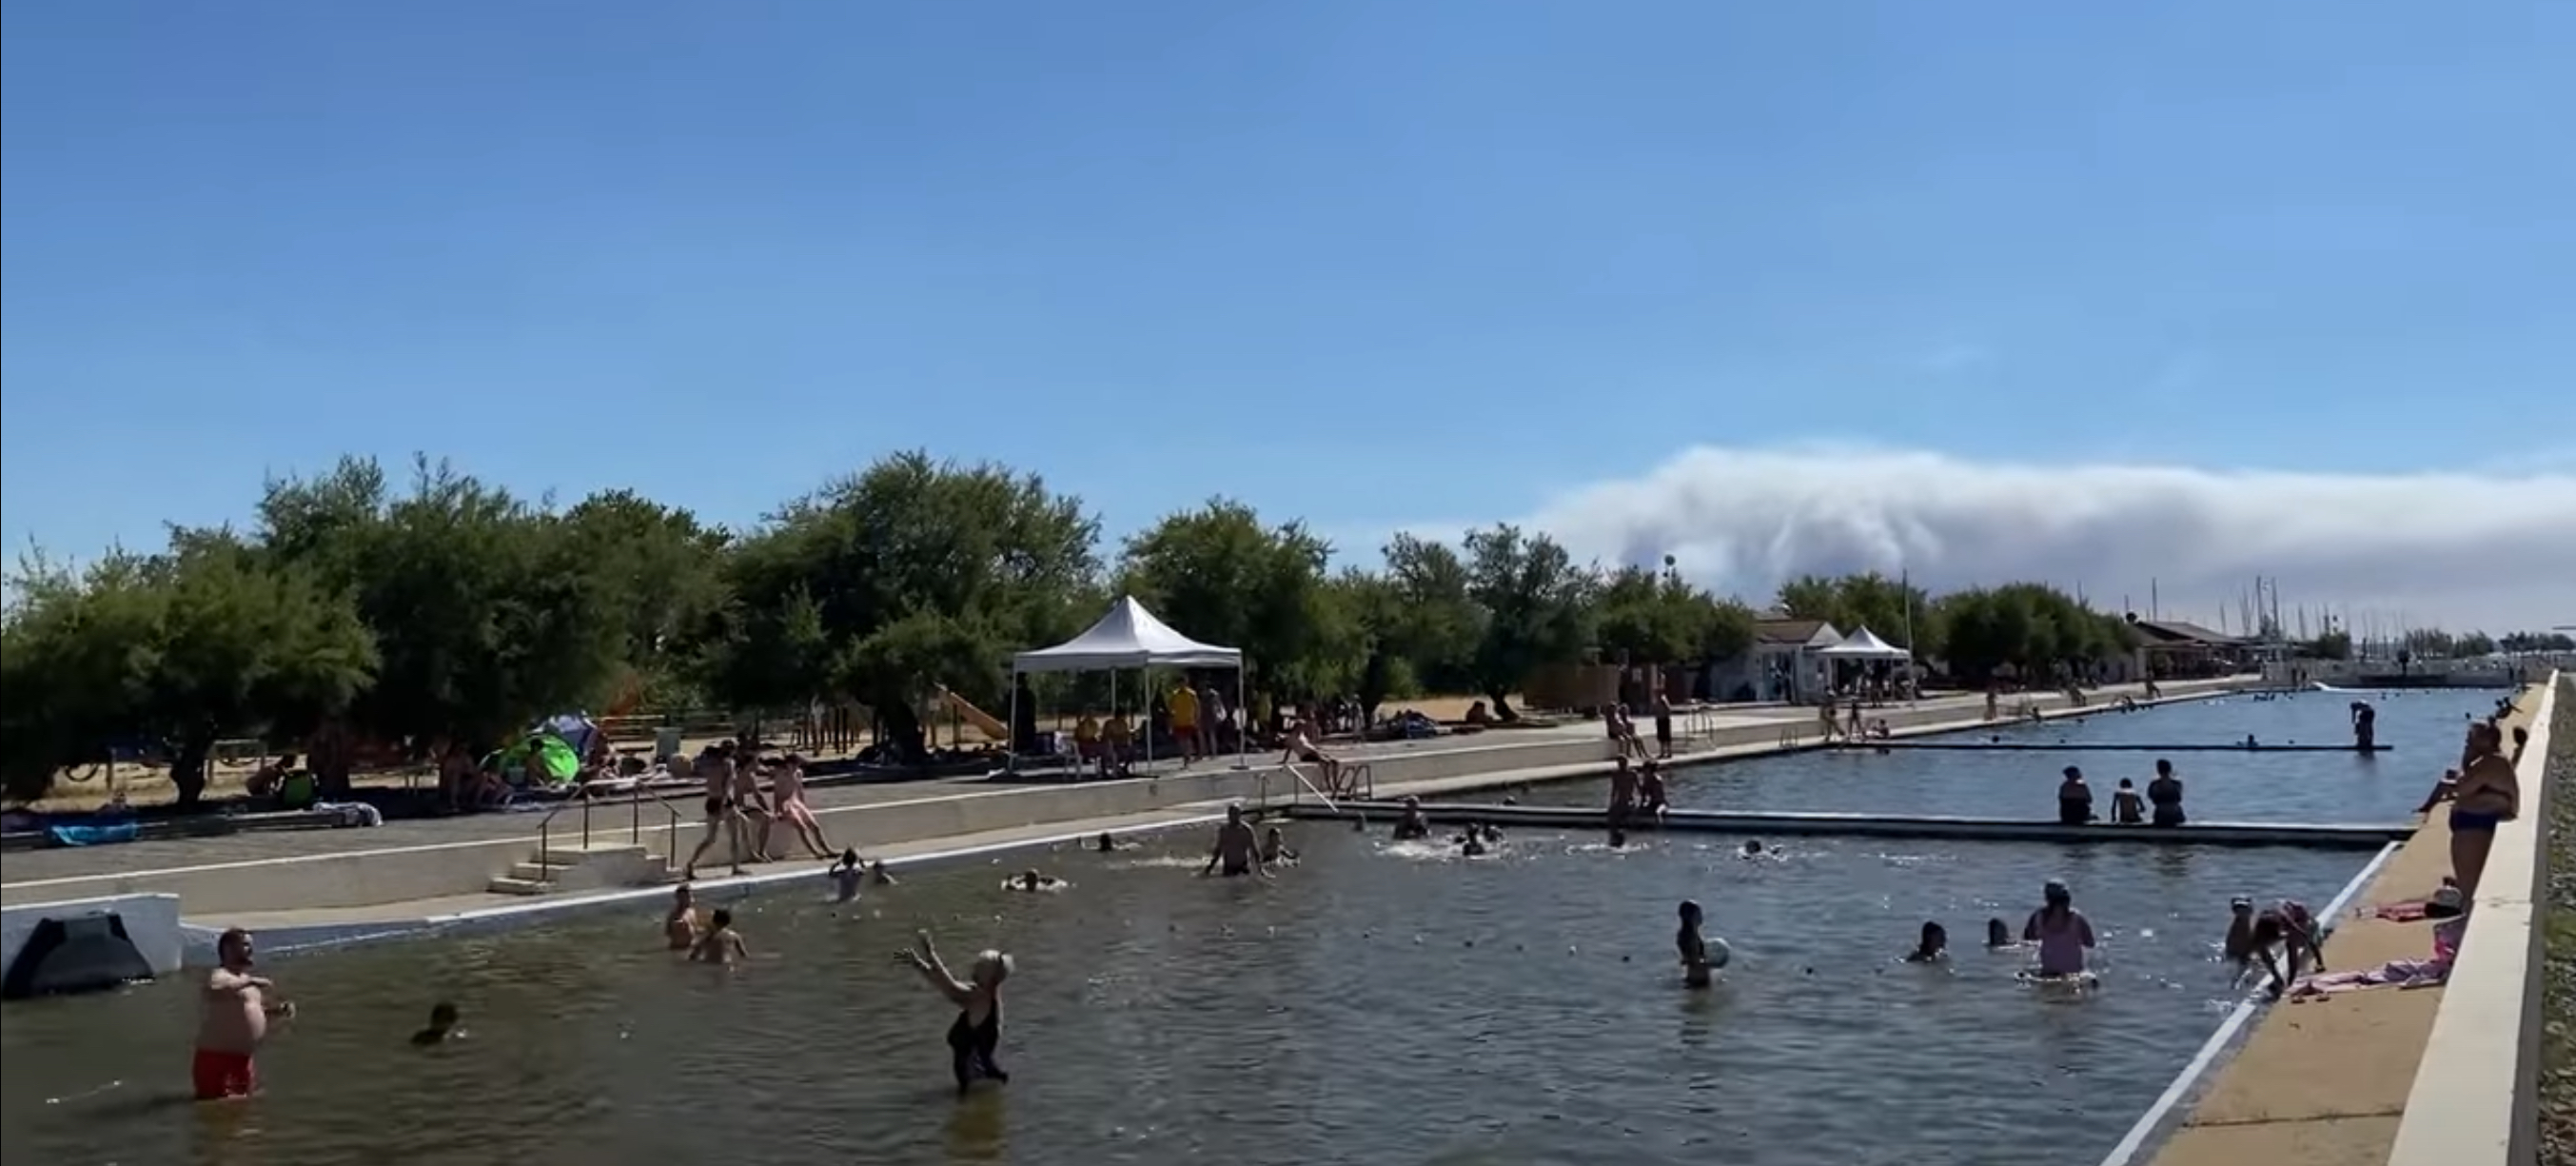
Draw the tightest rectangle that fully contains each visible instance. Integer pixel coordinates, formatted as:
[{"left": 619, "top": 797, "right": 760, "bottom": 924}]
[{"left": 1514, "top": 690, "right": 2499, "bottom": 823}]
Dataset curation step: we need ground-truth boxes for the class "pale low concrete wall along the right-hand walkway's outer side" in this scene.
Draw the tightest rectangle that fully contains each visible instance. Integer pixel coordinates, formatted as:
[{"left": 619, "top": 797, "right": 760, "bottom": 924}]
[{"left": 2388, "top": 677, "right": 2561, "bottom": 1166}]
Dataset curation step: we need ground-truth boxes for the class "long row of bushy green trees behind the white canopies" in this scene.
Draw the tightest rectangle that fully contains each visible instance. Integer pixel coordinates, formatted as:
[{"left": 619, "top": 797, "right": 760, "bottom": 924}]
[{"left": 0, "top": 453, "right": 2128, "bottom": 800}]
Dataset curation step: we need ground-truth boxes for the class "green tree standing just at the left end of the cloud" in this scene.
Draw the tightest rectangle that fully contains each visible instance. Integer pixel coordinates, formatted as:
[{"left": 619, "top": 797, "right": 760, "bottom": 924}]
[{"left": 1465, "top": 525, "right": 1595, "bottom": 721}]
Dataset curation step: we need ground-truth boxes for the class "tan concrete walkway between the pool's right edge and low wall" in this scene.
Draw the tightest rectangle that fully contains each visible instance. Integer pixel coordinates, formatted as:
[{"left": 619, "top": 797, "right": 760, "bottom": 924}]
[{"left": 2153, "top": 687, "right": 2540, "bottom": 1166}]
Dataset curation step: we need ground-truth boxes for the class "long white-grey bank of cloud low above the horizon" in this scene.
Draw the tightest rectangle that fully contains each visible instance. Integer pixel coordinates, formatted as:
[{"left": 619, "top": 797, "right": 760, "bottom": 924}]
[{"left": 1411, "top": 445, "right": 2576, "bottom": 631}]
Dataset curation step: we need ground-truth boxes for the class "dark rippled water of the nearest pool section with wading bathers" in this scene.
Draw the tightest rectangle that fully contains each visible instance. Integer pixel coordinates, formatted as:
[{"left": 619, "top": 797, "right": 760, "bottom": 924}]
[{"left": 0, "top": 823, "right": 2368, "bottom": 1166}]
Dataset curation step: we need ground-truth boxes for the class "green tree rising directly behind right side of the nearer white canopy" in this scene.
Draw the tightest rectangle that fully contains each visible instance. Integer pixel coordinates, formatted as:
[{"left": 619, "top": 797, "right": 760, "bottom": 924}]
[{"left": 1121, "top": 500, "right": 1363, "bottom": 698}]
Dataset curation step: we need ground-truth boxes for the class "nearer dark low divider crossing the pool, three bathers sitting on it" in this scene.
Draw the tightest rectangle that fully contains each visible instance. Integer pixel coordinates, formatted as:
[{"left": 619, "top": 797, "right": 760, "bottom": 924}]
[{"left": 1288, "top": 800, "right": 2413, "bottom": 849}]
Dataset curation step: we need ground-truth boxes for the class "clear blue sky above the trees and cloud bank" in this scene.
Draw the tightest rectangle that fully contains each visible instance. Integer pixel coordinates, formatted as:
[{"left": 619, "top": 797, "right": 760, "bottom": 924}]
[{"left": 0, "top": 0, "right": 2576, "bottom": 609}]
